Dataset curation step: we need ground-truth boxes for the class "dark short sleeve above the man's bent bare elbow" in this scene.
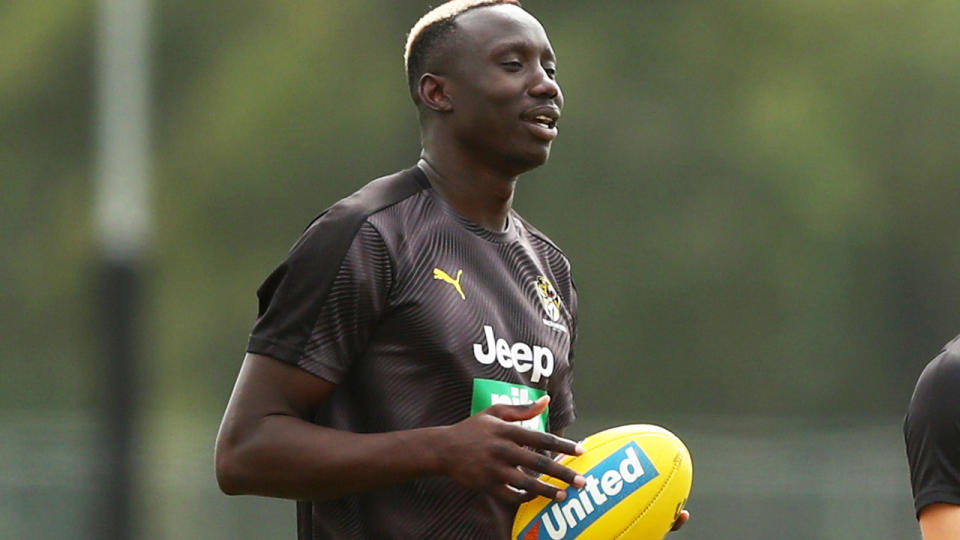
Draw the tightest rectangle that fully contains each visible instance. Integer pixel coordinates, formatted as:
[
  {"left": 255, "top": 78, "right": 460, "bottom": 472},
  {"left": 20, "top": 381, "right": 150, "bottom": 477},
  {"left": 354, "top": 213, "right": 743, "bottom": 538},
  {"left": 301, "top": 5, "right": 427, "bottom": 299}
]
[{"left": 247, "top": 222, "right": 392, "bottom": 383}]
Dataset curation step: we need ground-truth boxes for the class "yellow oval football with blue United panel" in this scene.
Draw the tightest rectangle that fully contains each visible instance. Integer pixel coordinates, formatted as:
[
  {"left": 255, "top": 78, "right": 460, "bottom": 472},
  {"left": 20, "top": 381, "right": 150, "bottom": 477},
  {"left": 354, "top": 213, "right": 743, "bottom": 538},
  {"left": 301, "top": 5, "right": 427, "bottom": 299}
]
[{"left": 511, "top": 424, "right": 693, "bottom": 540}]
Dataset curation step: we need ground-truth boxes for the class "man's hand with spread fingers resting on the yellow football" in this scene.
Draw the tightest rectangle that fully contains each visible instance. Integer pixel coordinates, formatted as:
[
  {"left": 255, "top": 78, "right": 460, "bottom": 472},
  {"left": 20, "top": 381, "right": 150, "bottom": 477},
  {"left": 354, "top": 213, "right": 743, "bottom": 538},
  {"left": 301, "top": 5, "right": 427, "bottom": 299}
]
[{"left": 436, "top": 396, "right": 586, "bottom": 504}]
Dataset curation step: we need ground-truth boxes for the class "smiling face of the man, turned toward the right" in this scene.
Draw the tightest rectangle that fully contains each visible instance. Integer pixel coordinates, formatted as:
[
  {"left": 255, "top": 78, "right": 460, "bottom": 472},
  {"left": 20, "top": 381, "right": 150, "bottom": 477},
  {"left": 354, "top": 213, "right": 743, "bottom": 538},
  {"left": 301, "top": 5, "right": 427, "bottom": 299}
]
[{"left": 448, "top": 5, "right": 563, "bottom": 174}]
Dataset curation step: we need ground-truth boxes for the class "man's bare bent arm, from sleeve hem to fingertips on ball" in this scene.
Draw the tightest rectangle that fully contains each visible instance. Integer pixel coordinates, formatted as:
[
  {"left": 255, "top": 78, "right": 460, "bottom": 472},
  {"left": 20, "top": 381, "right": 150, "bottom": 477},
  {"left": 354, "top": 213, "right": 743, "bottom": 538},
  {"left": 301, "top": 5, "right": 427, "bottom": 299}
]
[{"left": 216, "top": 354, "right": 584, "bottom": 502}]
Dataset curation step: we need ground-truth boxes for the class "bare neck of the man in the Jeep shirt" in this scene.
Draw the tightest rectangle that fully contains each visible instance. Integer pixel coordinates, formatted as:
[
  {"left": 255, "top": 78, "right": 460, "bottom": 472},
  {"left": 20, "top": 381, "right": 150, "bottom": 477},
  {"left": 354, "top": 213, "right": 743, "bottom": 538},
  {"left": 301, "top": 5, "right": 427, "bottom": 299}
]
[{"left": 419, "top": 150, "right": 517, "bottom": 231}]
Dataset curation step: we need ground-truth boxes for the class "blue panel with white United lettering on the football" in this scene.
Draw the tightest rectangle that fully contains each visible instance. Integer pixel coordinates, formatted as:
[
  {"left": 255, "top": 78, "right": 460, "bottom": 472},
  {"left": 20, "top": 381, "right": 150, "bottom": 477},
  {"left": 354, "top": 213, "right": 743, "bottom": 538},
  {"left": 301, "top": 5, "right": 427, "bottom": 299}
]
[{"left": 520, "top": 441, "right": 660, "bottom": 540}]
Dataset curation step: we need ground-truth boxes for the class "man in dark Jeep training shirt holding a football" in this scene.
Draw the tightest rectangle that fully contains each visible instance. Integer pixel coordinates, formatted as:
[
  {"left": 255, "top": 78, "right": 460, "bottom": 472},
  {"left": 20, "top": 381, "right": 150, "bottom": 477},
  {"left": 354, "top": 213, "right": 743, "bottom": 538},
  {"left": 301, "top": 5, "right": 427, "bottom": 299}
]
[{"left": 216, "top": 0, "right": 687, "bottom": 538}]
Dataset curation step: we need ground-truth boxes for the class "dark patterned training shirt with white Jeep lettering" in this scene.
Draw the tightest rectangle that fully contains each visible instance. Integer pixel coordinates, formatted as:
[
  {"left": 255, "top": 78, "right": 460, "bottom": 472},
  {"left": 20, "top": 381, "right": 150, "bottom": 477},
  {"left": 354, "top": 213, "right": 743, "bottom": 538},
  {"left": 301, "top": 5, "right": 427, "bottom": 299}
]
[{"left": 248, "top": 167, "right": 577, "bottom": 539}]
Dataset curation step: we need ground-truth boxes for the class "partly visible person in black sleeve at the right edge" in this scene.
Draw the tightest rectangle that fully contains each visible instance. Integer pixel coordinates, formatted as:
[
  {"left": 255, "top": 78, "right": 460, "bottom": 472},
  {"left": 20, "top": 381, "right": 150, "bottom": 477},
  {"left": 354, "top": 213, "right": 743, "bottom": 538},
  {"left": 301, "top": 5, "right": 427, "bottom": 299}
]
[{"left": 903, "top": 336, "right": 960, "bottom": 540}]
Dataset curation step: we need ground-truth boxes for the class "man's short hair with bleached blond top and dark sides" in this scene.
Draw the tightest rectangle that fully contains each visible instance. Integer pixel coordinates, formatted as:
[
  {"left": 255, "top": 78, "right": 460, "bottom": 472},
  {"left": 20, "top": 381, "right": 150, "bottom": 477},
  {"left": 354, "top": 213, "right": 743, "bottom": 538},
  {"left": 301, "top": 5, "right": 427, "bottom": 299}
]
[{"left": 403, "top": 0, "right": 520, "bottom": 103}]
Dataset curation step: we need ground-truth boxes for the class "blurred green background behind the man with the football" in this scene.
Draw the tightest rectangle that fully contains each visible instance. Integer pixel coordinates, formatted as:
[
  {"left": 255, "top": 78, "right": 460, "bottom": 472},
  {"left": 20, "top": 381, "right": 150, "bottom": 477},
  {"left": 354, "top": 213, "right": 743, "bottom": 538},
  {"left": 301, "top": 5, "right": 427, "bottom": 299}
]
[{"left": 0, "top": 0, "right": 960, "bottom": 540}]
